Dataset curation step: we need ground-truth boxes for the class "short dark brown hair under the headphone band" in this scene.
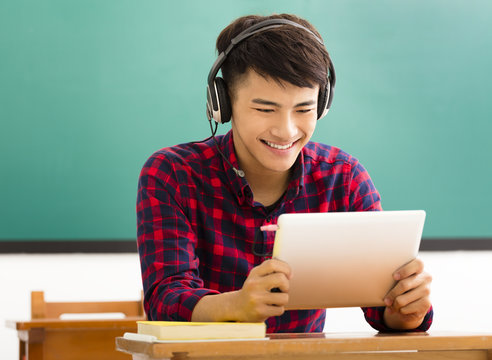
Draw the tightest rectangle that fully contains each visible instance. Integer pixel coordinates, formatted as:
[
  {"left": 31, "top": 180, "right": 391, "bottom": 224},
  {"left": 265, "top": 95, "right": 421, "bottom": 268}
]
[{"left": 217, "top": 14, "right": 329, "bottom": 96}]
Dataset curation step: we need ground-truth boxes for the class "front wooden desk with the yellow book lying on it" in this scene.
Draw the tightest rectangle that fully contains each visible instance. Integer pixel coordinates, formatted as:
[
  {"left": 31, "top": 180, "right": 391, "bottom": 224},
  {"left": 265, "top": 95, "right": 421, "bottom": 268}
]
[{"left": 116, "top": 333, "right": 492, "bottom": 360}]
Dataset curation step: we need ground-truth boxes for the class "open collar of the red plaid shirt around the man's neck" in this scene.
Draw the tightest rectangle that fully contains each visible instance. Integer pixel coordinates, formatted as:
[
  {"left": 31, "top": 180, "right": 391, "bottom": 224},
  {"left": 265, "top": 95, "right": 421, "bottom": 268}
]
[{"left": 218, "top": 130, "right": 304, "bottom": 205}]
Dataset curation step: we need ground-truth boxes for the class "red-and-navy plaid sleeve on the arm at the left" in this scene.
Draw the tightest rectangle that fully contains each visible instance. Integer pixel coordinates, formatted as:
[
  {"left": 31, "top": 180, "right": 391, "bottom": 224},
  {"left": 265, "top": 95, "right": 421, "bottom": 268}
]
[{"left": 137, "top": 155, "right": 218, "bottom": 321}]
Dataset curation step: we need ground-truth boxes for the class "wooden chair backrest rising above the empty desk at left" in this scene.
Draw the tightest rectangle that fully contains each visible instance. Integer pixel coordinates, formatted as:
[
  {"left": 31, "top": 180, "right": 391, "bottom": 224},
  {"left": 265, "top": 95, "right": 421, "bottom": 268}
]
[{"left": 31, "top": 291, "right": 145, "bottom": 319}]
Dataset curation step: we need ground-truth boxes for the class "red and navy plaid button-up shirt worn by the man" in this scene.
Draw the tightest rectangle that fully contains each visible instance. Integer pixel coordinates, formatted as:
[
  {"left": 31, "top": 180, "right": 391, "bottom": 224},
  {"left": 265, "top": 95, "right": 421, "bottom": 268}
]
[{"left": 137, "top": 132, "right": 432, "bottom": 332}]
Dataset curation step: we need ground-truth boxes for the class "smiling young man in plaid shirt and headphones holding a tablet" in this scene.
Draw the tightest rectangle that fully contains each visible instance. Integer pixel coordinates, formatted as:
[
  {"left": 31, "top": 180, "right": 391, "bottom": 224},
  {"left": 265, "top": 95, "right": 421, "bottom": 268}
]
[{"left": 137, "top": 15, "right": 432, "bottom": 332}]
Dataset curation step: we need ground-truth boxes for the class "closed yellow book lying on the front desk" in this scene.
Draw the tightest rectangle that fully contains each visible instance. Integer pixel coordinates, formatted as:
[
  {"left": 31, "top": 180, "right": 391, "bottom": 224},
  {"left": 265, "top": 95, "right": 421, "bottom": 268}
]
[{"left": 137, "top": 321, "right": 266, "bottom": 340}]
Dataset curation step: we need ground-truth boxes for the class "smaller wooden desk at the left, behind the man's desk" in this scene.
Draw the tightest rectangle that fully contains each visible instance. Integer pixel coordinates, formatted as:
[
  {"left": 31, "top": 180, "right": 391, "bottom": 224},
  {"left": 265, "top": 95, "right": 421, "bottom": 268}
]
[{"left": 7, "top": 317, "right": 144, "bottom": 360}]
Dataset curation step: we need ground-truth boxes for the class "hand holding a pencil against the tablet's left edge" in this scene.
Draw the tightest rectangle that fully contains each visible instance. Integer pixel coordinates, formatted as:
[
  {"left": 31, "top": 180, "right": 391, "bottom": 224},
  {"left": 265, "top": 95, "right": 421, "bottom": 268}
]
[{"left": 235, "top": 259, "right": 292, "bottom": 322}]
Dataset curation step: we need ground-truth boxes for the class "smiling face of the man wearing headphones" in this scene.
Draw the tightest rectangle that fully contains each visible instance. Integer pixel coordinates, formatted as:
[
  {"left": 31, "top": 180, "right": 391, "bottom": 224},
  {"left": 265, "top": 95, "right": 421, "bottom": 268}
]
[{"left": 232, "top": 70, "right": 319, "bottom": 175}]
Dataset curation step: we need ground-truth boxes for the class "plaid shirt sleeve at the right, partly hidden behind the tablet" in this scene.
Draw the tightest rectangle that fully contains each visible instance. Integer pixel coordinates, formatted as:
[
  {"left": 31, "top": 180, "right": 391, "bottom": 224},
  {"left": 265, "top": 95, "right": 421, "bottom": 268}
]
[{"left": 349, "top": 162, "right": 434, "bottom": 332}]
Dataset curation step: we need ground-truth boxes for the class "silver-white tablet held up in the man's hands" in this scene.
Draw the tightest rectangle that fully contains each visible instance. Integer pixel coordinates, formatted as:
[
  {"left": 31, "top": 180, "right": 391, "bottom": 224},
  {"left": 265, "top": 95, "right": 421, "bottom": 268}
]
[{"left": 273, "top": 210, "right": 425, "bottom": 310}]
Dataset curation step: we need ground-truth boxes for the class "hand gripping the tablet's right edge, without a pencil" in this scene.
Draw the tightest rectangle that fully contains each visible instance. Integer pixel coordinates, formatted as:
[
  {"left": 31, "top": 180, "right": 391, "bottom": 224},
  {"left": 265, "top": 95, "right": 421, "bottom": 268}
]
[{"left": 384, "top": 259, "right": 432, "bottom": 330}]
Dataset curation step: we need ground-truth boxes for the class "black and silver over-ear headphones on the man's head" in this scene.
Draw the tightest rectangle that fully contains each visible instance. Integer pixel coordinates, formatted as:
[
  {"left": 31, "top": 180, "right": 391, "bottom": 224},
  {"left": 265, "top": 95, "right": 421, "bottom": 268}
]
[{"left": 207, "top": 19, "right": 336, "bottom": 124}]
